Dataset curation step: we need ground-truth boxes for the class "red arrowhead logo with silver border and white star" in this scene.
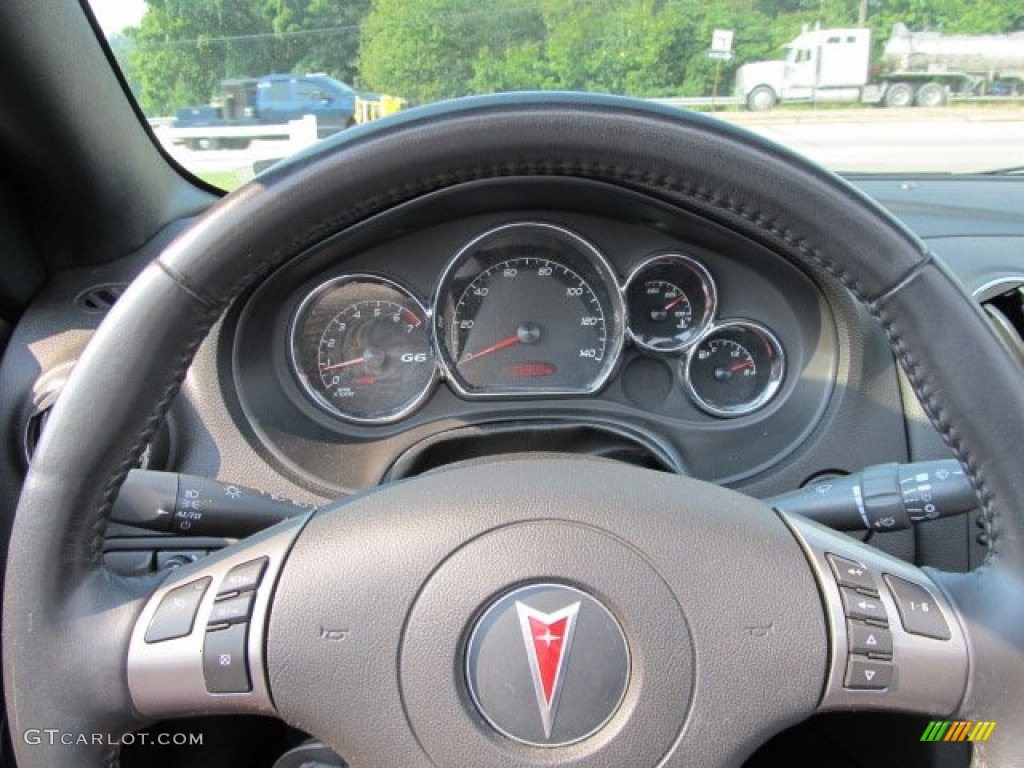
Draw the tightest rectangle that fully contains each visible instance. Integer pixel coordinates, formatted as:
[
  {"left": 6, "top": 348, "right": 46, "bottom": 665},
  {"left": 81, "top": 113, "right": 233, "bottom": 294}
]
[{"left": 515, "top": 601, "right": 580, "bottom": 738}]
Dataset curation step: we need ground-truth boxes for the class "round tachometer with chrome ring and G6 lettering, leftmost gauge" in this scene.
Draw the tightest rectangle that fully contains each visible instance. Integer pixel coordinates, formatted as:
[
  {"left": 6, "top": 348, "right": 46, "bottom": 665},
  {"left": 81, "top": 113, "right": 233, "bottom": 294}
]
[{"left": 291, "top": 274, "right": 437, "bottom": 424}]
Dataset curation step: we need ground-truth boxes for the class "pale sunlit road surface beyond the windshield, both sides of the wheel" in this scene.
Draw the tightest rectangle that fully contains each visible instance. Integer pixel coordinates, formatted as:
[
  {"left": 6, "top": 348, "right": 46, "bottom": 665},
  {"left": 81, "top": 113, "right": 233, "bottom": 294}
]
[{"left": 158, "top": 106, "right": 1024, "bottom": 183}]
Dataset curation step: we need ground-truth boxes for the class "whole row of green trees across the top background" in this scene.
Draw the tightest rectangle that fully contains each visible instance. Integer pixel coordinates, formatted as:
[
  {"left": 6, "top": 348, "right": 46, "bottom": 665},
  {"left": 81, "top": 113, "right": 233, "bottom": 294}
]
[{"left": 119, "top": 0, "right": 1024, "bottom": 115}]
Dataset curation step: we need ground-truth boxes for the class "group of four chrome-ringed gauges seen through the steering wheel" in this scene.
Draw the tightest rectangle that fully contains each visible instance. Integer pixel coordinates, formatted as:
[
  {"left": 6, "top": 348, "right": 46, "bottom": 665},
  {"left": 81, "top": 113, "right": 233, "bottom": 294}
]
[{"left": 289, "top": 221, "right": 785, "bottom": 424}]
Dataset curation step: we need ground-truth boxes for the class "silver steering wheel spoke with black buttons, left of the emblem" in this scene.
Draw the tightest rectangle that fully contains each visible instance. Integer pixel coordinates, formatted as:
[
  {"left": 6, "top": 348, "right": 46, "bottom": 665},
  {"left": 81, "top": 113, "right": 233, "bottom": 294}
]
[{"left": 128, "top": 516, "right": 307, "bottom": 718}]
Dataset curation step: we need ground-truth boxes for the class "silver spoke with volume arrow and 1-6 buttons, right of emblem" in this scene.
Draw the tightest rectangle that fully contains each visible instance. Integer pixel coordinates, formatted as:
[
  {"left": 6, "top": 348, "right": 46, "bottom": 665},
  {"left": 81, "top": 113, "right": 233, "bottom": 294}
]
[{"left": 782, "top": 514, "right": 969, "bottom": 716}]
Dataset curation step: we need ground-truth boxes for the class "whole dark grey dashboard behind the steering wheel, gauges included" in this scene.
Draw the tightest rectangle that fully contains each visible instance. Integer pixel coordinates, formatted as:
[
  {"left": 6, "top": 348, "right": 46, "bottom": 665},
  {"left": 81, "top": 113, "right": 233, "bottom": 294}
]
[{"left": 0, "top": 177, "right": 1024, "bottom": 581}]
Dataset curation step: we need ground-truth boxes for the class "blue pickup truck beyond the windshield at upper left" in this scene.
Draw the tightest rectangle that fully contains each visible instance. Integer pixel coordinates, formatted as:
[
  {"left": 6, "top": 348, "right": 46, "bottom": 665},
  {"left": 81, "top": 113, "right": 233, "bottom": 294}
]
[{"left": 173, "top": 74, "right": 356, "bottom": 150}]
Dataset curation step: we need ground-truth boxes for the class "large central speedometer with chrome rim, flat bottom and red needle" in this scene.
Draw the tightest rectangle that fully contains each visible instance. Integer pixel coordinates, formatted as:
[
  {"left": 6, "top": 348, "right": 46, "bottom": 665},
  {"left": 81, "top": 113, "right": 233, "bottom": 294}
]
[{"left": 434, "top": 222, "right": 624, "bottom": 396}]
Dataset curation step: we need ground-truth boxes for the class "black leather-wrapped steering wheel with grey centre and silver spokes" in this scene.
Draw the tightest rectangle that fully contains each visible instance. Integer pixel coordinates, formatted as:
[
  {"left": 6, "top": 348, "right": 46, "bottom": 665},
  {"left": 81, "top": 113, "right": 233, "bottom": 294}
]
[{"left": 3, "top": 94, "right": 1024, "bottom": 768}]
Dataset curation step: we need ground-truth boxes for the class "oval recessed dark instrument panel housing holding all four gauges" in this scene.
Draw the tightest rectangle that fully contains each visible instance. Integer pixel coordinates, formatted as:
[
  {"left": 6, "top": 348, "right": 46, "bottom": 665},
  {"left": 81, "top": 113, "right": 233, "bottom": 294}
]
[{"left": 224, "top": 180, "right": 839, "bottom": 495}]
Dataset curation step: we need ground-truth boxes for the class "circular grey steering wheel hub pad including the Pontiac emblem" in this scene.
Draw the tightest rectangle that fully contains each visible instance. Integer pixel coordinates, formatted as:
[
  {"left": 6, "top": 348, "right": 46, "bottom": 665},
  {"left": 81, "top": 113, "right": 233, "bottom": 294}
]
[{"left": 400, "top": 520, "right": 695, "bottom": 768}]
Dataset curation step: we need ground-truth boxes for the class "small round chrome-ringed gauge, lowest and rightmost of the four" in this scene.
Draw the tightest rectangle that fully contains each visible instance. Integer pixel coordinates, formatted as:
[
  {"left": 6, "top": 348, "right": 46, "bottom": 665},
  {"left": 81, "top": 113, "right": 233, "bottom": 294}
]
[{"left": 684, "top": 321, "right": 785, "bottom": 417}]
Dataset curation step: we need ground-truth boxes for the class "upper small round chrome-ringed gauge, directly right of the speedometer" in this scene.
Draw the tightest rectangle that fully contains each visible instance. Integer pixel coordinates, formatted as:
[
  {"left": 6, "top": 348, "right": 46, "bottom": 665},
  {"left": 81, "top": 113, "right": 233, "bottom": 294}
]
[{"left": 626, "top": 253, "right": 716, "bottom": 353}]
